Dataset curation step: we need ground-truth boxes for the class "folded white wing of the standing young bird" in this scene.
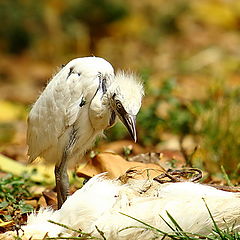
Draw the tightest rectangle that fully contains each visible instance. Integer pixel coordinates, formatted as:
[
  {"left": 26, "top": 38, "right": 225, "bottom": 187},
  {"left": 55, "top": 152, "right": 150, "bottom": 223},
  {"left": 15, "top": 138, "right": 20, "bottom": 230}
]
[{"left": 27, "top": 72, "right": 99, "bottom": 162}]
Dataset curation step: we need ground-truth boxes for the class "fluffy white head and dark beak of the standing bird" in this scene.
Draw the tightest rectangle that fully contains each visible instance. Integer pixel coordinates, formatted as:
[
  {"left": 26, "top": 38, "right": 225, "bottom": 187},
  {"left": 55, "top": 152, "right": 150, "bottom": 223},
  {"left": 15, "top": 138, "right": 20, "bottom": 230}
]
[{"left": 108, "top": 71, "right": 144, "bottom": 142}]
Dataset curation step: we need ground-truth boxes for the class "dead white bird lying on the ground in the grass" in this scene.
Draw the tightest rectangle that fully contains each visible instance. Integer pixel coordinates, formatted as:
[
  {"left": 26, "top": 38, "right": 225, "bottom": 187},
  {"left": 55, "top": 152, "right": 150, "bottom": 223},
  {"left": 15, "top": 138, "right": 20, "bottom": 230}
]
[{"left": 15, "top": 174, "right": 240, "bottom": 240}]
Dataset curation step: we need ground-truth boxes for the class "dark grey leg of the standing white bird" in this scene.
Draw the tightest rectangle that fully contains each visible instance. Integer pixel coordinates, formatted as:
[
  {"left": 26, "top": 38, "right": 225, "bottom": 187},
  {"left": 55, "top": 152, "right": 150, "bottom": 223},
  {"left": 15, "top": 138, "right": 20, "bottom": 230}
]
[{"left": 55, "top": 151, "right": 69, "bottom": 209}]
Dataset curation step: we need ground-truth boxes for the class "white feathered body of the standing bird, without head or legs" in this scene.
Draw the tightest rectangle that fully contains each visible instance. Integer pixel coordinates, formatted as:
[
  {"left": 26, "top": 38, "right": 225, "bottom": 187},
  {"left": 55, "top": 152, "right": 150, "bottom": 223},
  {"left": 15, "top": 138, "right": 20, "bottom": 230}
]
[{"left": 27, "top": 58, "right": 114, "bottom": 168}]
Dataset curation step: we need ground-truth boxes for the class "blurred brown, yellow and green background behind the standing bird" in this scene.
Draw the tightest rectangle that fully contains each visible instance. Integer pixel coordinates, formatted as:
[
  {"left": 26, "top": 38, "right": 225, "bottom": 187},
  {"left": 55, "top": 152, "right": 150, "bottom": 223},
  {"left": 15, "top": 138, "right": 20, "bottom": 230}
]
[{"left": 0, "top": 0, "right": 240, "bottom": 178}]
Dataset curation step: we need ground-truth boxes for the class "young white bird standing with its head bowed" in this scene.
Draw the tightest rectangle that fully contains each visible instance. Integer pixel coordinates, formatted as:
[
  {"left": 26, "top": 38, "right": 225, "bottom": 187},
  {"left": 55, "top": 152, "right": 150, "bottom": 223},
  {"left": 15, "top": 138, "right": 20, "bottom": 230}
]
[{"left": 27, "top": 57, "right": 143, "bottom": 208}]
